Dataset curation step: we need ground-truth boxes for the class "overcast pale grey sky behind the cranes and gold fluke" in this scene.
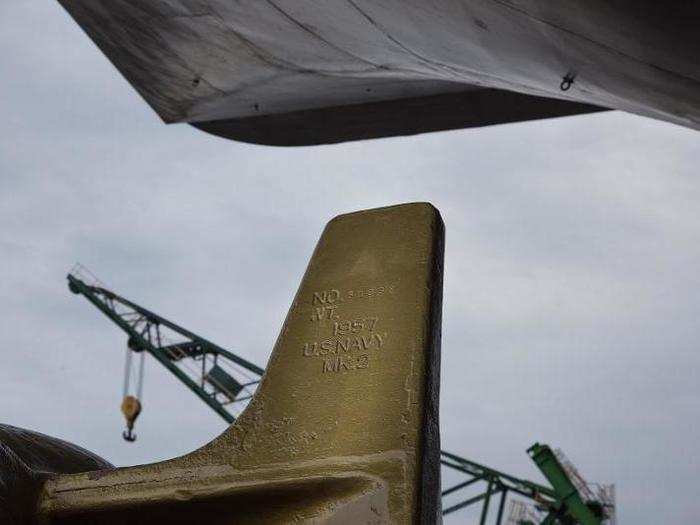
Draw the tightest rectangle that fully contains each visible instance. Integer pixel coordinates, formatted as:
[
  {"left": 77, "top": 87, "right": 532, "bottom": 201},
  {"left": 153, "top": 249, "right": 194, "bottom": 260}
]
[{"left": 0, "top": 0, "right": 700, "bottom": 525}]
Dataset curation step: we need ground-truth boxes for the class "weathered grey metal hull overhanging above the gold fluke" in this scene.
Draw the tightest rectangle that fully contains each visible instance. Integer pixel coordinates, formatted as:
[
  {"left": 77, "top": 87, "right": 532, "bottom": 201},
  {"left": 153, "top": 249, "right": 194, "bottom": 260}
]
[{"left": 59, "top": 0, "right": 700, "bottom": 144}]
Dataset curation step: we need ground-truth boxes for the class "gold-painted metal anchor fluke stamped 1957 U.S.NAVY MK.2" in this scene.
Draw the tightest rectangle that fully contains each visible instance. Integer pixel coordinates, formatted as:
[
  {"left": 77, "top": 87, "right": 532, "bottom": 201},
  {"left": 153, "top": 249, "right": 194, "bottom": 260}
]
[{"left": 27, "top": 204, "right": 443, "bottom": 525}]
